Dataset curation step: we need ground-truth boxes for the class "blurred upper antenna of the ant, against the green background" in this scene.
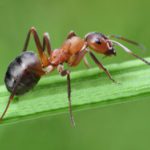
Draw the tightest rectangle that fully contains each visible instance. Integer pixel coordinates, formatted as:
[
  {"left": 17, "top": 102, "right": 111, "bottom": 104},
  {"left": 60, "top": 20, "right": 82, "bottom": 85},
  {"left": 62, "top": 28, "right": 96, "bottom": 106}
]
[{"left": 109, "top": 35, "right": 145, "bottom": 50}]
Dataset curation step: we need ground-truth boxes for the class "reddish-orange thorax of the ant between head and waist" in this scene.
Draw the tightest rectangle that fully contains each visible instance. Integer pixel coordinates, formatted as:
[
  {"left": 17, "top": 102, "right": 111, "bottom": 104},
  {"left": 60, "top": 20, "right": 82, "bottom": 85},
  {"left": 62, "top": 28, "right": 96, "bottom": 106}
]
[{"left": 50, "top": 36, "right": 85, "bottom": 66}]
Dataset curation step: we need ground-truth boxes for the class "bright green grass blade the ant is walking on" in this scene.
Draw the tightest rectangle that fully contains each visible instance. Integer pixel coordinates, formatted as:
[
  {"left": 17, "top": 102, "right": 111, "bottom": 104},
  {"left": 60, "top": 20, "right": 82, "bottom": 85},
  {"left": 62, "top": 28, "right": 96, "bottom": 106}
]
[{"left": 0, "top": 59, "right": 150, "bottom": 124}]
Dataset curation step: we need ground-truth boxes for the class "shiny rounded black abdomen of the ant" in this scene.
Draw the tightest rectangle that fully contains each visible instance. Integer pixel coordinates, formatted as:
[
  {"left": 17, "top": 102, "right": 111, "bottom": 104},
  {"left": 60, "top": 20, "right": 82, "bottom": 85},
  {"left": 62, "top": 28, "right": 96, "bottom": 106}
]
[{"left": 5, "top": 51, "right": 41, "bottom": 95}]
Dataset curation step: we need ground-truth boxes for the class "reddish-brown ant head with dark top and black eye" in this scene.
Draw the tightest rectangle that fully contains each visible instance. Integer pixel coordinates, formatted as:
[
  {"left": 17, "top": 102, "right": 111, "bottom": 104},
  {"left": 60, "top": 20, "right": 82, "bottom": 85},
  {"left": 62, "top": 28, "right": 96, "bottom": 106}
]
[{"left": 85, "top": 32, "right": 116, "bottom": 56}]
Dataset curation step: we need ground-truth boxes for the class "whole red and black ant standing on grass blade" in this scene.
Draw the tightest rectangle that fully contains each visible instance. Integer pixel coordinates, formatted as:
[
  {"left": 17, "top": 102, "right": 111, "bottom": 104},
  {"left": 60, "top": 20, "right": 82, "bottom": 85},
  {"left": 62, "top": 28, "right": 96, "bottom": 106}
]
[{"left": 0, "top": 27, "right": 150, "bottom": 126}]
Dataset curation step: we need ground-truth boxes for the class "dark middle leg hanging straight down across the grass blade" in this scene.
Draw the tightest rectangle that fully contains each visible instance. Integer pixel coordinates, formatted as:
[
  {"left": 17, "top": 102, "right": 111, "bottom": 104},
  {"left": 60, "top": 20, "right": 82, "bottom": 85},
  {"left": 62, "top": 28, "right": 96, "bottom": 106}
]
[{"left": 57, "top": 65, "right": 75, "bottom": 127}]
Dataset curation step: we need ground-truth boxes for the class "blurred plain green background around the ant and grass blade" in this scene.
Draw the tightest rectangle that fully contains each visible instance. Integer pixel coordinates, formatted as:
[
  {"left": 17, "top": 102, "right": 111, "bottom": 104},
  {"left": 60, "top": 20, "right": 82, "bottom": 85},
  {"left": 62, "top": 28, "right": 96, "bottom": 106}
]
[{"left": 0, "top": 0, "right": 150, "bottom": 150}]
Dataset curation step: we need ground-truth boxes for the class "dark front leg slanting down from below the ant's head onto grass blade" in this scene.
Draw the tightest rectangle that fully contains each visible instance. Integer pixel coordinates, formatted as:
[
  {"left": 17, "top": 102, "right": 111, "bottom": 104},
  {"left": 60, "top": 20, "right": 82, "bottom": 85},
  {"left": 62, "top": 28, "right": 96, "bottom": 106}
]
[{"left": 89, "top": 51, "right": 116, "bottom": 82}]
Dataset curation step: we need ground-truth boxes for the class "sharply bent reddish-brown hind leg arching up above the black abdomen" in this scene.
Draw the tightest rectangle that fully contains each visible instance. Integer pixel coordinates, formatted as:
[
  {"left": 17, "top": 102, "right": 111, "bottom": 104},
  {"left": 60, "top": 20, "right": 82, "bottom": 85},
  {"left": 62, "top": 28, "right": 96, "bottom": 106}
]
[{"left": 23, "top": 27, "right": 49, "bottom": 67}]
